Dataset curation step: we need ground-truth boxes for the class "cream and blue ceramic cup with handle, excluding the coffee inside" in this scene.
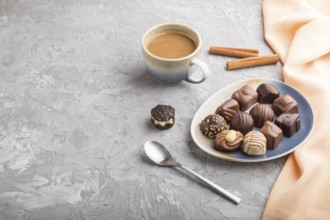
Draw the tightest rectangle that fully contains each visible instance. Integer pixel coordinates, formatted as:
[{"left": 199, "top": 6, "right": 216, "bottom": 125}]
[{"left": 142, "top": 23, "right": 209, "bottom": 83}]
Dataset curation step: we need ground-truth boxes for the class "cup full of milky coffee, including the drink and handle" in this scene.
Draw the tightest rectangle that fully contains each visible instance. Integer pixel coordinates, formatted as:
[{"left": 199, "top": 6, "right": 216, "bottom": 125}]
[{"left": 142, "top": 23, "right": 209, "bottom": 83}]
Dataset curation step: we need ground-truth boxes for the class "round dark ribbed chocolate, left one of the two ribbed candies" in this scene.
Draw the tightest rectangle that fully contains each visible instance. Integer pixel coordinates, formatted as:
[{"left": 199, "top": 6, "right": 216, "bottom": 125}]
[{"left": 230, "top": 111, "right": 254, "bottom": 134}]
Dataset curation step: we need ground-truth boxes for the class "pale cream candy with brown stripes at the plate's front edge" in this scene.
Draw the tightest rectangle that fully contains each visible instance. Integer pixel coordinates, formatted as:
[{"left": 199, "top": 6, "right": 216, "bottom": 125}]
[{"left": 242, "top": 131, "right": 267, "bottom": 156}]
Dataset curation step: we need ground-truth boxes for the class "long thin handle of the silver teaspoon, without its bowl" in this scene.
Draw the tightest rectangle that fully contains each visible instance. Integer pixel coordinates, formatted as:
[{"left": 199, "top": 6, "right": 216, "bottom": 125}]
[{"left": 177, "top": 164, "right": 241, "bottom": 204}]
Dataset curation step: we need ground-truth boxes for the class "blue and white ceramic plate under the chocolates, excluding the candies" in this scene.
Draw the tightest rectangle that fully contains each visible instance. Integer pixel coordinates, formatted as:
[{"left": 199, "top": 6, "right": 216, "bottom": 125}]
[{"left": 190, "top": 79, "right": 314, "bottom": 162}]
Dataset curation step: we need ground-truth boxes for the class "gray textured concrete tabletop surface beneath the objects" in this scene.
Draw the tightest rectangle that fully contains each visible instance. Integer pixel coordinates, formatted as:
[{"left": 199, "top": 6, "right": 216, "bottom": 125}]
[{"left": 0, "top": 0, "right": 285, "bottom": 220}]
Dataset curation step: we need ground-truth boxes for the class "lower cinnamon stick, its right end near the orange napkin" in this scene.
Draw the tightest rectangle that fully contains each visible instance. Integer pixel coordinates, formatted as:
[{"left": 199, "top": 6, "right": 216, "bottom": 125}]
[{"left": 227, "top": 54, "right": 280, "bottom": 70}]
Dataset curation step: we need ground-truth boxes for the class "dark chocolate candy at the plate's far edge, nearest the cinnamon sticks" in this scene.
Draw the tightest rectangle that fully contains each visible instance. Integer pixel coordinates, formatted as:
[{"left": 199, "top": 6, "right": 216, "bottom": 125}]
[{"left": 257, "top": 83, "right": 280, "bottom": 104}]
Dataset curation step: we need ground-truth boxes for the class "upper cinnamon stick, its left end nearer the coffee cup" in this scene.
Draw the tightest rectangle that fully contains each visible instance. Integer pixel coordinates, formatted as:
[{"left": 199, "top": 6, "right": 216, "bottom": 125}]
[{"left": 209, "top": 46, "right": 259, "bottom": 58}]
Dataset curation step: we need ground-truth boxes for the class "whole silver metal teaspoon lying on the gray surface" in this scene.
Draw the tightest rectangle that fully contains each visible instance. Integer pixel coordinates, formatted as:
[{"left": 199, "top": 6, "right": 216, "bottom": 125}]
[{"left": 144, "top": 140, "right": 241, "bottom": 204}]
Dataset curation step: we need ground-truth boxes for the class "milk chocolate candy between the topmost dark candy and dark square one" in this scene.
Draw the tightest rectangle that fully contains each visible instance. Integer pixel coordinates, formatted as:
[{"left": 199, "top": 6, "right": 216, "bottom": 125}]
[{"left": 272, "top": 95, "right": 298, "bottom": 115}]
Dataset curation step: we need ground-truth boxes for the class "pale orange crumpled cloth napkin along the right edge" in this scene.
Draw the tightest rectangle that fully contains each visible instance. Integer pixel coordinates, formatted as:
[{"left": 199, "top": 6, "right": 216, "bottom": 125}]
[{"left": 263, "top": 0, "right": 330, "bottom": 220}]
